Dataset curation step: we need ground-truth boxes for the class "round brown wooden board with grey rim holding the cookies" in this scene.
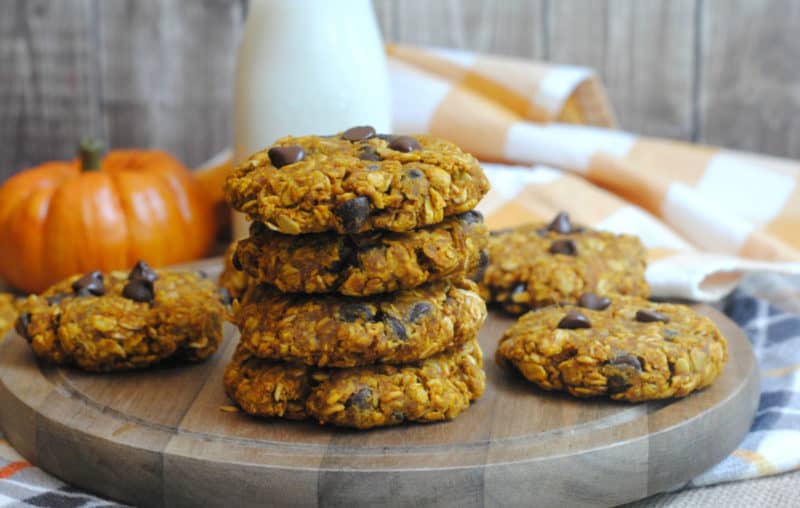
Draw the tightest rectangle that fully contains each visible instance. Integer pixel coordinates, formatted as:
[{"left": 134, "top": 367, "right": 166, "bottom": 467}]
[{"left": 0, "top": 265, "right": 759, "bottom": 507}]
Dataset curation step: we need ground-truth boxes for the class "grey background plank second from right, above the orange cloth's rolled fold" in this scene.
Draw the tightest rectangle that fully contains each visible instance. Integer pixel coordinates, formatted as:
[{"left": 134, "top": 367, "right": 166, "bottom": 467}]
[{"left": 548, "top": 0, "right": 696, "bottom": 139}]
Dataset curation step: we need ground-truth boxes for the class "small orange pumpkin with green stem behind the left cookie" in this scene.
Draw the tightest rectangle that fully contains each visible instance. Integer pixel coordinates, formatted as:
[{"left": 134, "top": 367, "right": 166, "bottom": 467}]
[{"left": 0, "top": 141, "right": 216, "bottom": 292}]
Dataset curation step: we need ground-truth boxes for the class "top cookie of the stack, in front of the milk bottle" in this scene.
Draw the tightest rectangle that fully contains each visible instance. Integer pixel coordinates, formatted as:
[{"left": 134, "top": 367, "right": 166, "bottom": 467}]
[{"left": 225, "top": 127, "right": 489, "bottom": 235}]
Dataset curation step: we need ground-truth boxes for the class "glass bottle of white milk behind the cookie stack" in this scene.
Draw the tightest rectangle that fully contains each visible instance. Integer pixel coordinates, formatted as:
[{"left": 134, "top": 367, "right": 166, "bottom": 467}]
[{"left": 233, "top": 0, "right": 391, "bottom": 238}]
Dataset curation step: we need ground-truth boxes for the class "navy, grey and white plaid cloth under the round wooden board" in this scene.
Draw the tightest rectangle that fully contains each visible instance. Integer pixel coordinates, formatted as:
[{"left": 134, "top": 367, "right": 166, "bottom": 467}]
[{"left": 0, "top": 274, "right": 800, "bottom": 508}]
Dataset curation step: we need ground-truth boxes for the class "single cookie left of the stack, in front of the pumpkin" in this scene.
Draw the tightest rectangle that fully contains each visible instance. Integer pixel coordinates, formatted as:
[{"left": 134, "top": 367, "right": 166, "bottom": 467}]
[{"left": 16, "top": 261, "right": 226, "bottom": 372}]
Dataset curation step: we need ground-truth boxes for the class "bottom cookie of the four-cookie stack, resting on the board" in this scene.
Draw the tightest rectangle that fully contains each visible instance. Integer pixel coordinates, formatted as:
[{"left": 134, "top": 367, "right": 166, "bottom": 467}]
[{"left": 224, "top": 340, "right": 486, "bottom": 429}]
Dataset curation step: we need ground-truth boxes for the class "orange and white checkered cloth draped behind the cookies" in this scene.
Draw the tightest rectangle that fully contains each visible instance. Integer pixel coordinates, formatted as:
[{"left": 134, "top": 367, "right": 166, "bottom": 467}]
[{"left": 388, "top": 46, "right": 800, "bottom": 301}]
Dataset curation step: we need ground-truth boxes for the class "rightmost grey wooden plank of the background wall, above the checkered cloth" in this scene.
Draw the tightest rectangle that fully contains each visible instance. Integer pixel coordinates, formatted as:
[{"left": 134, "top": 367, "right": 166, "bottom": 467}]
[{"left": 698, "top": 0, "right": 800, "bottom": 158}]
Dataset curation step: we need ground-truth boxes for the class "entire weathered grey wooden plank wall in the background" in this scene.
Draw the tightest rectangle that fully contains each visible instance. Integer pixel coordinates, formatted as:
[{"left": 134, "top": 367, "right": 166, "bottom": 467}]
[{"left": 0, "top": 0, "right": 800, "bottom": 180}]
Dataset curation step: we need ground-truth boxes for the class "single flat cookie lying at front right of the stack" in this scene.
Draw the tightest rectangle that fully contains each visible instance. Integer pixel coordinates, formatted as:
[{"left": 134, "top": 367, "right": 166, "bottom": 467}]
[{"left": 496, "top": 294, "right": 728, "bottom": 402}]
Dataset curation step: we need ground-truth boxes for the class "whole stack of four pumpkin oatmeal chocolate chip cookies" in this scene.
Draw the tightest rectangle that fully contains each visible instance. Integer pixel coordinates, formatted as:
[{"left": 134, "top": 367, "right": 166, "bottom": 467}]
[{"left": 225, "top": 127, "right": 489, "bottom": 428}]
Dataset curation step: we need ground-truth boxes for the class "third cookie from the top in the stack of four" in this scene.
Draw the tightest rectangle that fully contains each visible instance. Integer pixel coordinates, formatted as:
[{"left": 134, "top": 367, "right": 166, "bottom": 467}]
[{"left": 233, "top": 280, "right": 486, "bottom": 367}]
